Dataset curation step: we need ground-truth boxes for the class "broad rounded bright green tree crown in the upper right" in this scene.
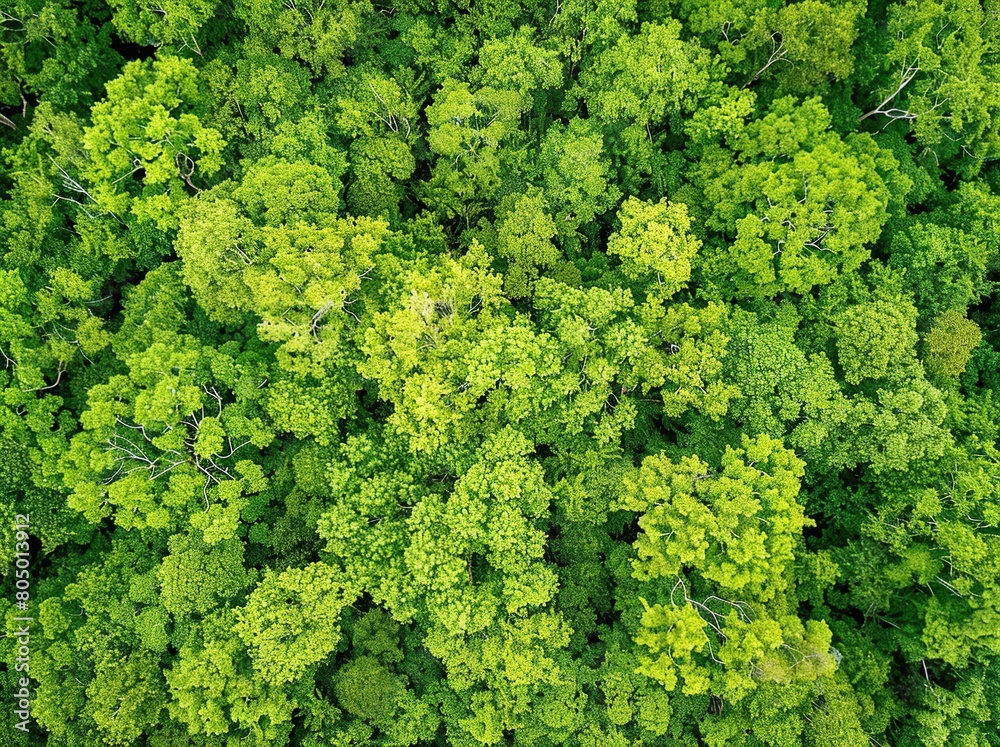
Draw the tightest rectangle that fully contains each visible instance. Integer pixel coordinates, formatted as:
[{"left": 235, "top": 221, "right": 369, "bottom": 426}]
[{"left": 691, "top": 98, "right": 891, "bottom": 297}]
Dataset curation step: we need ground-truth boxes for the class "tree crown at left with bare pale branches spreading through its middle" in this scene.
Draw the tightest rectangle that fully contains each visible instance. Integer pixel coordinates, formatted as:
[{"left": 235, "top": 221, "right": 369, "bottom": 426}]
[{"left": 61, "top": 265, "right": 273, "bottom": 543}]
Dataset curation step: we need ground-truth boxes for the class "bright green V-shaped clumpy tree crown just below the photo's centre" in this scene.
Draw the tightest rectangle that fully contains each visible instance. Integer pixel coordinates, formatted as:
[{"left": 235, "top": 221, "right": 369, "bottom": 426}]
[{"left": 320, "top": 431, "right": 555, "bottom": 634}]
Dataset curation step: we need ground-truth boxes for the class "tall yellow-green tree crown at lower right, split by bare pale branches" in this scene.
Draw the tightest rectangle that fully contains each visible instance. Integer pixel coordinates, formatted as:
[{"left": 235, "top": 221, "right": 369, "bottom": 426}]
[{"left": 623, "top": 436, "right": 835, "bottom": 712}]
